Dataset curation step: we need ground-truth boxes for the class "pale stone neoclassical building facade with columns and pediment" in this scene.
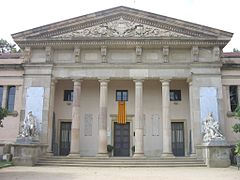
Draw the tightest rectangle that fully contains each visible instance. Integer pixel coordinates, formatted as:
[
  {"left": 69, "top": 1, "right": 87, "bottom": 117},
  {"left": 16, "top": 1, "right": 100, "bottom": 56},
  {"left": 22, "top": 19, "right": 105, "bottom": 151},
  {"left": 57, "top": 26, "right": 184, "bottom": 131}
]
[{"left": 0, "top": 7, "right": 240, "bottom": 157}]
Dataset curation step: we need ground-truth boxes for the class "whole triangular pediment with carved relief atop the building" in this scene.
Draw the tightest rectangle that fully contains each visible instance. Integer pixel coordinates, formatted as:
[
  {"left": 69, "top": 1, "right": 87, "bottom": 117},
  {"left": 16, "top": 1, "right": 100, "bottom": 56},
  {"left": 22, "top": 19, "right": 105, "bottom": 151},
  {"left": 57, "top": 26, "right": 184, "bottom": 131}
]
[{"left": 12, "top": 6, "right": 233, "bottom": 42}]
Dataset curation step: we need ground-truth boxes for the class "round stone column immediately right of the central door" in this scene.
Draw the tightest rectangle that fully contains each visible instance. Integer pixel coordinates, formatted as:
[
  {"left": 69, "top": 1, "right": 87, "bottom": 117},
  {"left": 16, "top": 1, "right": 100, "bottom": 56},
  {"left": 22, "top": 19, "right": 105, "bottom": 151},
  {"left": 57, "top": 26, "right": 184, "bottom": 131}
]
[{"left": 133, "top": 80, "right": 144, "bottom": 158}]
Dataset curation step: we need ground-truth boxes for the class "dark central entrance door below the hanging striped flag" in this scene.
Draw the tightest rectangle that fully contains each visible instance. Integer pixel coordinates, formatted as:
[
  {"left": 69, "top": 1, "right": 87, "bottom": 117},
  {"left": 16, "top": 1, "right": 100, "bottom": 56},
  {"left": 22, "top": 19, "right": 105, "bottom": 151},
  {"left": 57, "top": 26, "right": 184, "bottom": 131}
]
[{"left": 114, "top": 122, "right": 130, "bottom": 156}]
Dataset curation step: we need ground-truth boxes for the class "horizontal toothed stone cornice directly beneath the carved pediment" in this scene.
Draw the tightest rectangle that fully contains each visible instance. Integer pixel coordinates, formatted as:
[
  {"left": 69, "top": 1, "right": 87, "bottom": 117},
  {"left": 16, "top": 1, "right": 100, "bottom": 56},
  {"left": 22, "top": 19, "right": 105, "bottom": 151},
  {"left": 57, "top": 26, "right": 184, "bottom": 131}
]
[{"left": 17, "top": 38, "right": 228, "bottom": 48}]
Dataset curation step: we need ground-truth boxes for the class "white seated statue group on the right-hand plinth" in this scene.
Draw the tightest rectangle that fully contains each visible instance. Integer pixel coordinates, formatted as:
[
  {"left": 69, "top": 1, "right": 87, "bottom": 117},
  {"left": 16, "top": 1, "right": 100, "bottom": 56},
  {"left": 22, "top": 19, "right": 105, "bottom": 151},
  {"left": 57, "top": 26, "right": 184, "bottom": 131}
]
[{"left": 203, "top": 112, "right": 224, "bottom": 142}]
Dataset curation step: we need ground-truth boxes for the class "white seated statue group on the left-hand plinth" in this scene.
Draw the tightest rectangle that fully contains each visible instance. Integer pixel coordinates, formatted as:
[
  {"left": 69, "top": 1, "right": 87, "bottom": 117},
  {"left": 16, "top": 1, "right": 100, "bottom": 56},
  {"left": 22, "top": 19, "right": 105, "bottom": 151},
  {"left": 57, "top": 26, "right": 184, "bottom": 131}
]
[{"left": 20, "top": 111, "right": 38, "bottom": 137}]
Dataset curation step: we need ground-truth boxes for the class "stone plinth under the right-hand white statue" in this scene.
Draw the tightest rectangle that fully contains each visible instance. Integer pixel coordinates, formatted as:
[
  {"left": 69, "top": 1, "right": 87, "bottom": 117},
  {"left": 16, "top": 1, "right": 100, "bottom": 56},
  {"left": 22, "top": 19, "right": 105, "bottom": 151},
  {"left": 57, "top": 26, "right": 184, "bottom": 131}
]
[{"left": 197, "top": 140, "right": 231, "bottom": 168}]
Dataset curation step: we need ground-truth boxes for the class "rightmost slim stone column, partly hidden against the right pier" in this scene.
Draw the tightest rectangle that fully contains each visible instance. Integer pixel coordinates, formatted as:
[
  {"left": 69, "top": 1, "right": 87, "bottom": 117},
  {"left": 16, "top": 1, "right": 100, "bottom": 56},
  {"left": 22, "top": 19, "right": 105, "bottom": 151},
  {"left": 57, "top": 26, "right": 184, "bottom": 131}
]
[{"left": 188, "top": 79, "right": 196, "bottom": 156}]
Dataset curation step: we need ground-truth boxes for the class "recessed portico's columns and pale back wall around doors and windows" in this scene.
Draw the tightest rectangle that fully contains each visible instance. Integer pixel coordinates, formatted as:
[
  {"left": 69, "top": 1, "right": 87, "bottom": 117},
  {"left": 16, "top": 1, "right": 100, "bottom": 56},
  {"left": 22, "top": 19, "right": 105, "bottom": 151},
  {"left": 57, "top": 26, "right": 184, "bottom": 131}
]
[{"left": 44, "top": 78, "right": 190, "bottom": 158}]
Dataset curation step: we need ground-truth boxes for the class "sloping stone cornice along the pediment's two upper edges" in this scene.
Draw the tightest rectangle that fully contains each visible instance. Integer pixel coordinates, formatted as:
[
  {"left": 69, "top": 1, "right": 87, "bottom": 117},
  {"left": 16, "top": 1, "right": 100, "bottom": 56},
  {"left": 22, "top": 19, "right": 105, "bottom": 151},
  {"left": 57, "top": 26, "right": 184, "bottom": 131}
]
[{"left": 12, "top": 6, "right": 233, "bottom": 42}]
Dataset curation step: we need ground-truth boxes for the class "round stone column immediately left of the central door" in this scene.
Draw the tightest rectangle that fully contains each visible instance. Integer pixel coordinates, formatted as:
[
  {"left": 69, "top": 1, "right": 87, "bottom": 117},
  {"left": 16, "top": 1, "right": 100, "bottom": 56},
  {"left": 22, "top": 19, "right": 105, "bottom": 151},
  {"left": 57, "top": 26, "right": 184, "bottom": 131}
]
[{"left": 97, "top": 79, "right": 109, "bottom": 157}]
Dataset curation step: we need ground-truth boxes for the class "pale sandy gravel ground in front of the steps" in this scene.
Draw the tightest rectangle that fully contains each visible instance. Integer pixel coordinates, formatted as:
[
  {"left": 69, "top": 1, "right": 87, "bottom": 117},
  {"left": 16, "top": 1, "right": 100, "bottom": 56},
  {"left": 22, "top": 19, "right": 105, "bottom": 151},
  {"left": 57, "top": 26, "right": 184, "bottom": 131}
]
[{"left": 0, "top": 166, "right": 240, "bottom": 180}]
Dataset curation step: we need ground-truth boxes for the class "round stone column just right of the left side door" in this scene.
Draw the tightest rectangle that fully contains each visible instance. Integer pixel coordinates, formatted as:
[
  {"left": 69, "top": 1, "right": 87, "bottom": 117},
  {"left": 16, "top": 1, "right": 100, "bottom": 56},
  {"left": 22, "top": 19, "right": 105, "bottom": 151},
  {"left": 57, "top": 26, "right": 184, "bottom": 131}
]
[{"left": 70, "top": 80, "right": 82, "bottom": 156}]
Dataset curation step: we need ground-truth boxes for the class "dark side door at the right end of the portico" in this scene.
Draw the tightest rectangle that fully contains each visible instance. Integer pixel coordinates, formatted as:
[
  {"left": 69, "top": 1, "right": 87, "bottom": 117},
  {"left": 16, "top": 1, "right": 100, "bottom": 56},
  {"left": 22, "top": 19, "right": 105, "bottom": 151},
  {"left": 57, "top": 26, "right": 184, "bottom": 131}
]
[{"left": 172, "top": 122, "right": 185, "bottom": 156}]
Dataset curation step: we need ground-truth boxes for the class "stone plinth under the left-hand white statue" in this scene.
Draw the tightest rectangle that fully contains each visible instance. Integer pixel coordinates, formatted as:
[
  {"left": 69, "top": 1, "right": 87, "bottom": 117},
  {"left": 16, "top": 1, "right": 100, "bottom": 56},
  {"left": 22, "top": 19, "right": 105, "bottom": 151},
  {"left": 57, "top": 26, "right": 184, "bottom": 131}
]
[{"left": 13, "top": 143, "right": 48, "bottom": 166}]
